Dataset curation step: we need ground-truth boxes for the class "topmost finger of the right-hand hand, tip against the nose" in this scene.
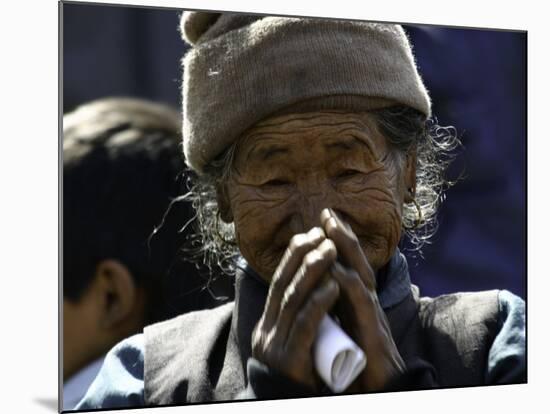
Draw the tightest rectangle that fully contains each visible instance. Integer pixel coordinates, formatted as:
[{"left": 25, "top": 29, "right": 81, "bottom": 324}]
[{"left": 321, "top": 208, "right": 376, "bottom": 292}]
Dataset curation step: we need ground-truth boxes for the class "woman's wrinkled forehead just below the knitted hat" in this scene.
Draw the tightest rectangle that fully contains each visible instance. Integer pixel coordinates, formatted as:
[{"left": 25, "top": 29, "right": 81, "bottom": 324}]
[{"left": 236, "top": 111, "right": 387, "bottom": 166}]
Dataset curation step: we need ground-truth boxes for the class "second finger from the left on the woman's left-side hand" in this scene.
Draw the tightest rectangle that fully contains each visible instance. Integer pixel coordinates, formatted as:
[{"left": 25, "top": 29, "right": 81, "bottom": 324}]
[{"left": 277, "top": 239, "right": 336, "bottom": 338}]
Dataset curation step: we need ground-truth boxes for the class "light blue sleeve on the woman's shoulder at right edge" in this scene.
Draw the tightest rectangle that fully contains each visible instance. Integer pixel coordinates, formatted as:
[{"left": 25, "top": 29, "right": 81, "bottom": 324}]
[{"left": 486, "top": 290, "right": 527, "bottom": 384}]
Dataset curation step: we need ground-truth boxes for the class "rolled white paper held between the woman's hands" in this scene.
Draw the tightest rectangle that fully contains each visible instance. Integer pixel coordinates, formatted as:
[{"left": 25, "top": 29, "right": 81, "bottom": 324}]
[{"left": 313, "top": 315, "right": 367, "bottom": 393}]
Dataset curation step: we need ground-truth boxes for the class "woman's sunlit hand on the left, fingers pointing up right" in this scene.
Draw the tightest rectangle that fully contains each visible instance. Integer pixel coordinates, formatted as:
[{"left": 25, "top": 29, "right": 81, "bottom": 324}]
[{"left": 252, "top": 228, "right": 340, "bottom": 390}]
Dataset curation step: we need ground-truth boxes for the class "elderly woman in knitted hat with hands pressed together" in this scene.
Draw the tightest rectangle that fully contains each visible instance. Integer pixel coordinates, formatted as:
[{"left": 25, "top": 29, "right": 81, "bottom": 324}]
[{"left": 79, "top": 12, "right": 525, "bottom": 408}]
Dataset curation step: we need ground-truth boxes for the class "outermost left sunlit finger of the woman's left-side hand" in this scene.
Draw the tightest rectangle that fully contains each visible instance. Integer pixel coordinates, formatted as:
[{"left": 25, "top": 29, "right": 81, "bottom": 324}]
[{"left": 261, "top": 227, "right": 326, "bottom": 329}]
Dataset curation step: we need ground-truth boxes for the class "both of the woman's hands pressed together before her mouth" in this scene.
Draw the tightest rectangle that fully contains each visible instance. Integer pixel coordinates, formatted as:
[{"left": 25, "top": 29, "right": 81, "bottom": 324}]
[{"left": 252, "top": 209, "right": 405, "bottom": 392}]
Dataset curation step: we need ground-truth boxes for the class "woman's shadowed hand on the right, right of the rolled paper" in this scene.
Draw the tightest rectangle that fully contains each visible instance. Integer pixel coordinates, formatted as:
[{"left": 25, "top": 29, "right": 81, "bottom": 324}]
[{"left": 321, "top": 209, "right": 405, "bottom": 392}]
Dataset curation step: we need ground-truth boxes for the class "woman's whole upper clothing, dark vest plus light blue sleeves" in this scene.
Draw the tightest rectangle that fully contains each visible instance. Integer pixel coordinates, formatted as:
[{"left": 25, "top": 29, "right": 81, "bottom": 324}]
[{"left": 76, "top": 252, "right": 526, "bottom": 409}]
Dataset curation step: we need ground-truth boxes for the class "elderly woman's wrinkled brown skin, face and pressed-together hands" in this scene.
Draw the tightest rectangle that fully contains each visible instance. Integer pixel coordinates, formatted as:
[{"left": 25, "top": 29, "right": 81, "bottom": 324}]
[{"left": 219, "top": 111, "right": 416, "bottom": 392}]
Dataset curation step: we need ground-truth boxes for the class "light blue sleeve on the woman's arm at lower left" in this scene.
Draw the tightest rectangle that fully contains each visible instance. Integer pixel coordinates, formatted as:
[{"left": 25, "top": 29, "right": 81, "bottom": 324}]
[{"left": 75, "top": 334, "right": 144, "bottom": 410}]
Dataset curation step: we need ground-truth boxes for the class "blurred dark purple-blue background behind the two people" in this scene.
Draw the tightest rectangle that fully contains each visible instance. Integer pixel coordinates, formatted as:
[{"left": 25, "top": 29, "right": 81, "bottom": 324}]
[{"left": 61, "top": 3, "right": 527, "bottom": 298}]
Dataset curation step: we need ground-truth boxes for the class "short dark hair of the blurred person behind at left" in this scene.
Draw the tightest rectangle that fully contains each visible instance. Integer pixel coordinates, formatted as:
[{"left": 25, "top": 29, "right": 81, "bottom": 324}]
[{"left": 63, "top": 98, "right": 231, "bottom": 322}]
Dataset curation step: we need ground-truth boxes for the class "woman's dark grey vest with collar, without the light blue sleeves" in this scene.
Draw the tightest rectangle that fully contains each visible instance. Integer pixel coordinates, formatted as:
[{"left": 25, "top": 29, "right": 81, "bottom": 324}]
[{"left": 144, "top": 254, "right": 525, "bottom": 405}]
